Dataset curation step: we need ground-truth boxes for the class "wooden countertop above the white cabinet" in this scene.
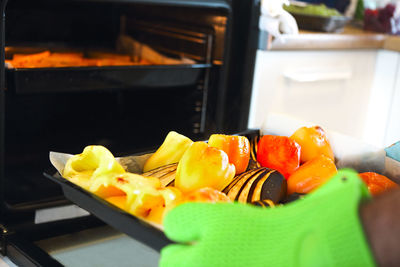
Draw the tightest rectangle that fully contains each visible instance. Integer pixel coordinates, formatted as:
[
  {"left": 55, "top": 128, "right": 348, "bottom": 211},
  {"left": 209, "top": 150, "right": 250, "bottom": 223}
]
[{"left": 268, "top": 26, "right": 400, "bottom": 51}]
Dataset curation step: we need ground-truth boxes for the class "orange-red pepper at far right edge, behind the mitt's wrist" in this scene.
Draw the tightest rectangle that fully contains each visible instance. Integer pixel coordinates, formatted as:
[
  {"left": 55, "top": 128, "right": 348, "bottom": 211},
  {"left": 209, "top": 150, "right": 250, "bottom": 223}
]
[{"left": 359, "top": 172, "right": 399, "bottom": 196}]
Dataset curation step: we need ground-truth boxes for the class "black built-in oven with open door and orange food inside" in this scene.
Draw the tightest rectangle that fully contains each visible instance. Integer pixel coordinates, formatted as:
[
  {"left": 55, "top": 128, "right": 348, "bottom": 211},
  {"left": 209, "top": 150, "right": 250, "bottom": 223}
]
[{"left": 0, "top": 0, "right": 260, "bottom": 266}]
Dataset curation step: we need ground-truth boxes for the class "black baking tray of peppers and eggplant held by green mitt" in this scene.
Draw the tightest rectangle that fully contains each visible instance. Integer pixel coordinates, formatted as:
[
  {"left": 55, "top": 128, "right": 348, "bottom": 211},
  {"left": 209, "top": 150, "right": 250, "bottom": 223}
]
[{"left": 43, "top": 129, "right": 260, "bottom": 251}]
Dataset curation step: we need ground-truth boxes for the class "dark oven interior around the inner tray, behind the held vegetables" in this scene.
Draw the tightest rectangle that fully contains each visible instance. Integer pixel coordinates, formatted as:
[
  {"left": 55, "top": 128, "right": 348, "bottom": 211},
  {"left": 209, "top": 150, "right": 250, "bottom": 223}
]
[{"left": 4, "top": 0, "right": 231, "bottom": 222}]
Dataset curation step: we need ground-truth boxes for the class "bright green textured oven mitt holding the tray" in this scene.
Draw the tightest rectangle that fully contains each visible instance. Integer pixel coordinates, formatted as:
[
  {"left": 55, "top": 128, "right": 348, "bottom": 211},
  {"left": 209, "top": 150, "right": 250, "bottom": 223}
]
[{"left": 160, "top": 170, "right": 374, "bottom": 267}]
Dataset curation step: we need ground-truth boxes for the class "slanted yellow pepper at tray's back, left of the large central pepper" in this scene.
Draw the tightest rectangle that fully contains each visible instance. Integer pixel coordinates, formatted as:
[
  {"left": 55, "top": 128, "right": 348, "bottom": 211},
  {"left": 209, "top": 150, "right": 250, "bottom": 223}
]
[{"left": 143, "top": 131, "right": 193, "bottom": 172}]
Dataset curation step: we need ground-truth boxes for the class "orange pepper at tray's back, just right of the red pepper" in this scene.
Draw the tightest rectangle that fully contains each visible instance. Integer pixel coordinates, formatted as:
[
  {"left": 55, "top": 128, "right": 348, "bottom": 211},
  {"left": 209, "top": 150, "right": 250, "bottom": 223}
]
[{"left": 290, "top": 126, "right": 335, "bottom": 163}]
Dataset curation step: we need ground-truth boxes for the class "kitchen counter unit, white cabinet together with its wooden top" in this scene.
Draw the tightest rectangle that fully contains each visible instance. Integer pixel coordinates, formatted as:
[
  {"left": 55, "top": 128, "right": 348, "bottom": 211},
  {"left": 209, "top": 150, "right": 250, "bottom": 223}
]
[{"left": 253, "top": 27, "right": 400, "bottom": 147}]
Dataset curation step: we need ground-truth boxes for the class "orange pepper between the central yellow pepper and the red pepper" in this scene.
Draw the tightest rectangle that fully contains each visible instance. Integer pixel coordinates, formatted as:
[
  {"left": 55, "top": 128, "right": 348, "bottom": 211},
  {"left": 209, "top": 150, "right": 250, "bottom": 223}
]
[{"left": 208, "top": 134, "right": 250, "bottom": 174}]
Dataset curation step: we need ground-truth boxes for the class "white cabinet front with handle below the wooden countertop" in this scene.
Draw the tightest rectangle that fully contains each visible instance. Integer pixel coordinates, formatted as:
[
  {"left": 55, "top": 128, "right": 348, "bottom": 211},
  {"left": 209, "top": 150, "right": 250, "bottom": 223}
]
[{"left": 249, "top": 50, "right": 400, "bottom": 146}]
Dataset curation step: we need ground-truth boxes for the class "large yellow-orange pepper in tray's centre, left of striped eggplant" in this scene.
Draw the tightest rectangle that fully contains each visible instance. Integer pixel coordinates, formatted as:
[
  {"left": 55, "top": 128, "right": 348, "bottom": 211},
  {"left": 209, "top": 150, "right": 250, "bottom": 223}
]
[{"left": 175, "top": 142, "right": 235, "bottom": 193}]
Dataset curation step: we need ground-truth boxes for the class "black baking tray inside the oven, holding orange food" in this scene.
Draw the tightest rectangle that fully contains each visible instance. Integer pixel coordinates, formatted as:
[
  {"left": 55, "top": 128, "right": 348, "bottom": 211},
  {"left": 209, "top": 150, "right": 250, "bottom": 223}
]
[{"left": 6, "top": 64, "right": 211, "bottom": 94}]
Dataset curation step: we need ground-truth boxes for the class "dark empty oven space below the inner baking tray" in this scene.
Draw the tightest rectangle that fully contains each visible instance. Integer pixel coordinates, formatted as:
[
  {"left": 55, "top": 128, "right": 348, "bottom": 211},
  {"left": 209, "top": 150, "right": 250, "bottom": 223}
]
[{"left": 6, "top": 86, "right": 206, "bottom": 204}]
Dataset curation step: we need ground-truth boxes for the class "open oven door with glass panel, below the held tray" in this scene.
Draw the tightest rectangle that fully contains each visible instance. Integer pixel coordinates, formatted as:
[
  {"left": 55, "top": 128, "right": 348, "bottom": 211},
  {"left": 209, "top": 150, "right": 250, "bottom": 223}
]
[{"left": 4, "top": 226, "right": 159, "bottom": 267}]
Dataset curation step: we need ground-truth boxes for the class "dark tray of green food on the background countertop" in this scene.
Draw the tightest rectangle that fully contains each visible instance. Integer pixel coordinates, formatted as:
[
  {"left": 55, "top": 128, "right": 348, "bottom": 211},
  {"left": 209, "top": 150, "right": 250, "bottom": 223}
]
[{"left": 290, "top": 12, "right": 350, "bottom": 32}]
